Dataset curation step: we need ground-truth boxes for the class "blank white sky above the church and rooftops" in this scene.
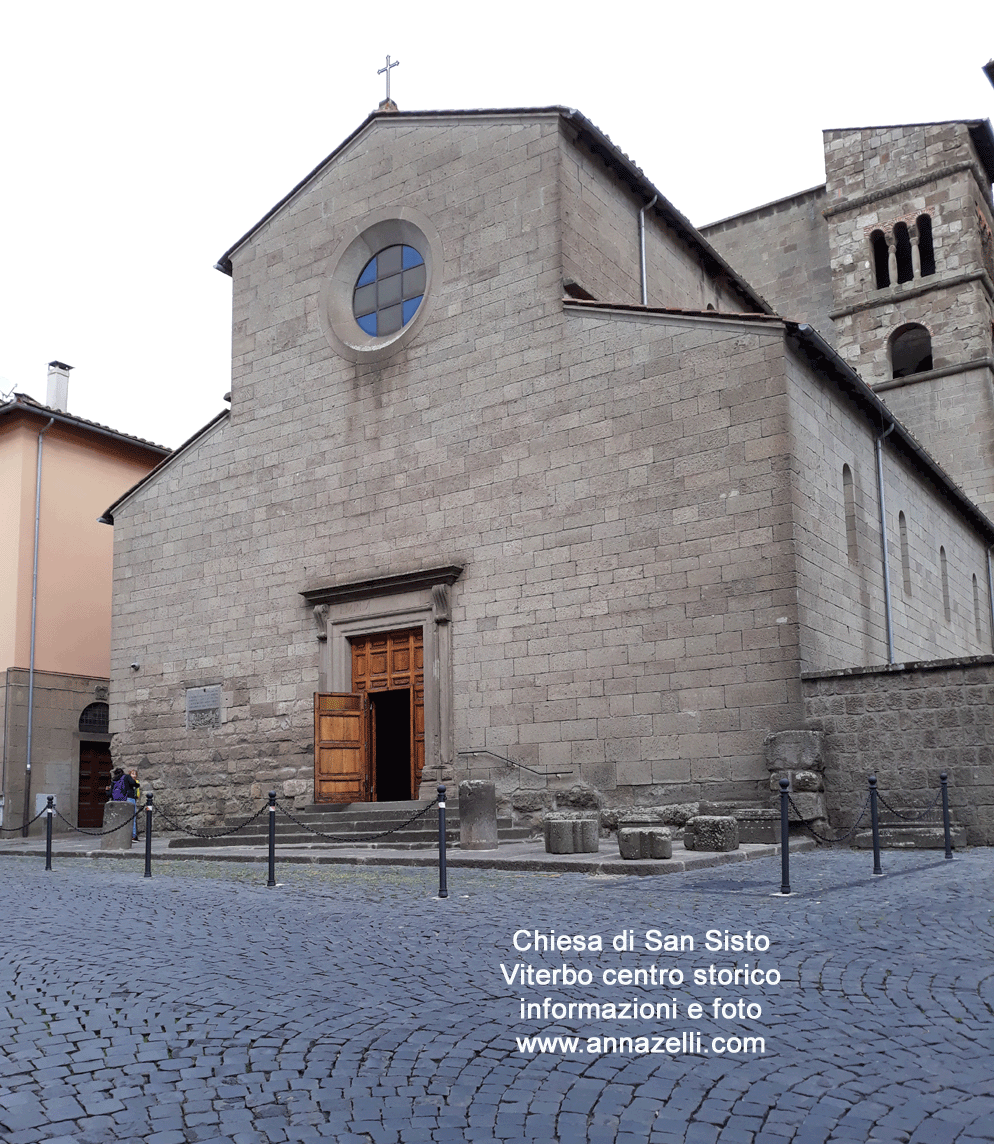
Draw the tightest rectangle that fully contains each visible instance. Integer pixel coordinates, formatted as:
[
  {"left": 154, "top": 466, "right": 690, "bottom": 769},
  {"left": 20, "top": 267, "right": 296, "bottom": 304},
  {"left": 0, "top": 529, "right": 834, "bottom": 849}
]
[{"left": 0, "top": 0, "right": 994, "bottom": 446}]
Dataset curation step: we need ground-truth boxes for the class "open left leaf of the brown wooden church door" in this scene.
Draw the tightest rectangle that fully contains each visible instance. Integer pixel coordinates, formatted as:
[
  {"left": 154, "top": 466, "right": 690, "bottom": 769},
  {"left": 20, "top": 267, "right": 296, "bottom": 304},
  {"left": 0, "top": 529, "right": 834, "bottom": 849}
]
[{"left": 315, "top": 692, "right": 371, "bottom": 802}]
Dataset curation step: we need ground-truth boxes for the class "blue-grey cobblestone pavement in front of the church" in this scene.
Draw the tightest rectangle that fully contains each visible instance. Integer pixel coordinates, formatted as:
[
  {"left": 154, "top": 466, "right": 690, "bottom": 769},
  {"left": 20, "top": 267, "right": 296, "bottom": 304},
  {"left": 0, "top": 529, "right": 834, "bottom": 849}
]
[{"left": 0, "top": 850, "right": 994, "bottom": 1144}]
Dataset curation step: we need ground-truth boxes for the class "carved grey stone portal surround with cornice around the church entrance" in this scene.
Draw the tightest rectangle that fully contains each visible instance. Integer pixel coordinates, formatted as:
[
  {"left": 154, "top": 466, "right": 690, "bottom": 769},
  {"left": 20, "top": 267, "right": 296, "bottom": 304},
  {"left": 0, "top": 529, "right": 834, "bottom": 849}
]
[{"left": 301, "top": 564, "right": 463, "bottom": 797}]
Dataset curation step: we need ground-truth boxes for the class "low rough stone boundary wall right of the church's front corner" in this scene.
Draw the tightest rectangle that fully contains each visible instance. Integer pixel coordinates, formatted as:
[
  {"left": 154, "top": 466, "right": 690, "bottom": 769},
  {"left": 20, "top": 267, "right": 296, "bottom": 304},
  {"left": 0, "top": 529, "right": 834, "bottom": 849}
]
[{"left": 802, "top": 656, "right": 994, "bottom": 845}]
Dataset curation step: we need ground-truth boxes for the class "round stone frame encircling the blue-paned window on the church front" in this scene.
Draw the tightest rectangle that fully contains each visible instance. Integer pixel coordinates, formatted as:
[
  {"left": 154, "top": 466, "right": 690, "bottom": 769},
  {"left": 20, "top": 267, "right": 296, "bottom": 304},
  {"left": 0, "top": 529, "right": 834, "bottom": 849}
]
[{"left": 318, "top": 206, "right": 444, "bottom": 363}]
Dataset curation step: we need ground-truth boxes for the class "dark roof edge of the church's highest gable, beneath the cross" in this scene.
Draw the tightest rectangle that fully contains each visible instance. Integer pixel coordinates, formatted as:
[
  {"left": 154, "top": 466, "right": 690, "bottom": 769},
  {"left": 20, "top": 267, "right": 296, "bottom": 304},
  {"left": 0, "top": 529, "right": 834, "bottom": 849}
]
[{"left": 215, "top": 105, "right": 772, "bottom": 313}]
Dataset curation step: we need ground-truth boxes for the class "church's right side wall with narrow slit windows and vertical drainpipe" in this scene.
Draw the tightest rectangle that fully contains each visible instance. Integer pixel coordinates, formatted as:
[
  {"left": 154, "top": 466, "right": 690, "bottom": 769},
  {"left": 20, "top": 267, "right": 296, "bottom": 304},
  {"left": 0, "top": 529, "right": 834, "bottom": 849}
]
[{"left": 790, "top": 347, "right": 992, "bottom": 670}]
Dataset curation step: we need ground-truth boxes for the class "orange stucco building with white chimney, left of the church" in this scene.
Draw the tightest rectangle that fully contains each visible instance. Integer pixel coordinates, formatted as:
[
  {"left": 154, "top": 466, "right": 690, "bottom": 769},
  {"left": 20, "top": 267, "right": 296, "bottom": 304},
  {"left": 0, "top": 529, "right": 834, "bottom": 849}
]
[{"left": 0, "top": 362, "right": 169, "bottom": 831}]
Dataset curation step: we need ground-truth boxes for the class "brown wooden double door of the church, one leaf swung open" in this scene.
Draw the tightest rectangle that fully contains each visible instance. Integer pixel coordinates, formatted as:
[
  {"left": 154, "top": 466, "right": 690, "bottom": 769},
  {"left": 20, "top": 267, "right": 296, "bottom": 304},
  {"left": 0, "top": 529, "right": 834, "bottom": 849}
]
[{"left": 315, "top": 628, "right": 424, "bottom": 802}]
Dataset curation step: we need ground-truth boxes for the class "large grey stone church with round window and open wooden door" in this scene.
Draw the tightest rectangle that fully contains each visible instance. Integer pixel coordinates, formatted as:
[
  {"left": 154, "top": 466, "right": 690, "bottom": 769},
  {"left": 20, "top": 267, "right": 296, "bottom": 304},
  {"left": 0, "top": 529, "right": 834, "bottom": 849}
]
[{"left": 100, "top": 108, "right": 994, "bottom": 840}]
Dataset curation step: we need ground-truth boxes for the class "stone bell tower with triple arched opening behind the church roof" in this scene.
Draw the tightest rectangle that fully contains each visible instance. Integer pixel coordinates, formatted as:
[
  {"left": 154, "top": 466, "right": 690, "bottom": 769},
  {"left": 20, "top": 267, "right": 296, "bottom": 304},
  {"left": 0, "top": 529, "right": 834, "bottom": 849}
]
[{"left": 824, "top": 120, "right": 994, "bottom": 505}]
